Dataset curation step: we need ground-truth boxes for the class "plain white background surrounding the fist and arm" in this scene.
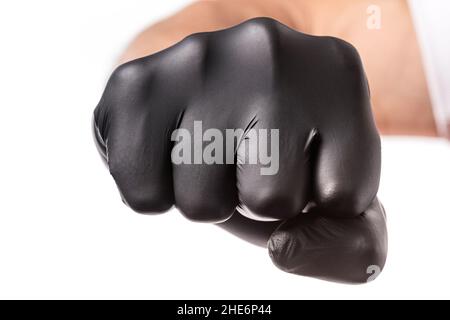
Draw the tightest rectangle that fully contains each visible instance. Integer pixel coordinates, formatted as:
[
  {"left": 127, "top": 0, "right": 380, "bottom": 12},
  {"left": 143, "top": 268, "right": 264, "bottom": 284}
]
[{"left": 0, "top": 0, "right": 450, "bottom": 299}]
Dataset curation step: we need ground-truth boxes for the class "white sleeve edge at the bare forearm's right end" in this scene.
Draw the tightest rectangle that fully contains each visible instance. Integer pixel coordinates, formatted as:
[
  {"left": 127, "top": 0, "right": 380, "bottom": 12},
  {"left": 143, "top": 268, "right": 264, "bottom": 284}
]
[{"left": 409, "top": 0, "right": 450, "bottom": 137}]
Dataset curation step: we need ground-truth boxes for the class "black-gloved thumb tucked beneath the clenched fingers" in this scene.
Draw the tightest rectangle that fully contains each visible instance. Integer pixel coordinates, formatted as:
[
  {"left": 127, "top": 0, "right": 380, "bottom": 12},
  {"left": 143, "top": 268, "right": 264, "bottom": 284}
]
[{"left": 268, "top": 199, "right": 387, "bottom": 283}]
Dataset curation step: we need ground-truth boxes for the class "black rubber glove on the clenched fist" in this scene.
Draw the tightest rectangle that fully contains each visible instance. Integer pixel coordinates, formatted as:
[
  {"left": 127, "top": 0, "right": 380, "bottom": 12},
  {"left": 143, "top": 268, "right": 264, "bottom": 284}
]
[{"left": 94, "top": 18, "right": 387, "bottom": 282}]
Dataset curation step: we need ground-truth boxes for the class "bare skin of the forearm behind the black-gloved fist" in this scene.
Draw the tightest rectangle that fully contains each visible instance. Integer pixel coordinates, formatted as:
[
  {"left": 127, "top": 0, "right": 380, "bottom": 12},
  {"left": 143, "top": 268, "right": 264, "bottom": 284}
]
[{"left": 120, "top": 0, "right": 437, "bottom": 136}]
